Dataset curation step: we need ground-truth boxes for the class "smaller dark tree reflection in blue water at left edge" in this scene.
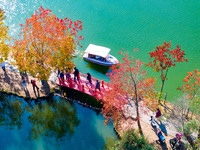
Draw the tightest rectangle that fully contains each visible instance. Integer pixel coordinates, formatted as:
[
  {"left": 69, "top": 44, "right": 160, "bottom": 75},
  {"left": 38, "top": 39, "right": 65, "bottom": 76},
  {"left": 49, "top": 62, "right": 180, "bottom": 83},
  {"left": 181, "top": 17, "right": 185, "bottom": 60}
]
[{"left": 0, "top": 93, "right": 24, "bottom": 129}]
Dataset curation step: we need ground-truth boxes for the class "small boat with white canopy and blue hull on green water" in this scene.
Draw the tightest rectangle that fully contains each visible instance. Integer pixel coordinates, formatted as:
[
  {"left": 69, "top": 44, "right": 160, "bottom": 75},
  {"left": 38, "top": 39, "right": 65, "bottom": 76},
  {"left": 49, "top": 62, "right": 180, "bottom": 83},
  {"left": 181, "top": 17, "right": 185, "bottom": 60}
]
[{"left": 83, "top": 44, "right": 119, "bottom": 66}]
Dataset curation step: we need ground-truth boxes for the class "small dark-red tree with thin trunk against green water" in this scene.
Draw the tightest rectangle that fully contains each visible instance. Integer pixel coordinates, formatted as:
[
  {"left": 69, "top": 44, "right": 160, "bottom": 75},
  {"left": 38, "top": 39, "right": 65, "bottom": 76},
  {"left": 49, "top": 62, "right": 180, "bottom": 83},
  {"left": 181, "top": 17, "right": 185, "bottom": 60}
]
[{"left": 146, "top": 41, "right": 188, "bottom": 103}]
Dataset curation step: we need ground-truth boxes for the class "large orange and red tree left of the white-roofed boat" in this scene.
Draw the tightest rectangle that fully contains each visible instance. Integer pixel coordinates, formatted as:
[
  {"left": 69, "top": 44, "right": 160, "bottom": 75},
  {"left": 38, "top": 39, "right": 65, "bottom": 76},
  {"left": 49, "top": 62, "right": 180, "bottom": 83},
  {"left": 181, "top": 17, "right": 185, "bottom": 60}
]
[{"left": 13, "top": 7, "right": 83, "bottom": 80}]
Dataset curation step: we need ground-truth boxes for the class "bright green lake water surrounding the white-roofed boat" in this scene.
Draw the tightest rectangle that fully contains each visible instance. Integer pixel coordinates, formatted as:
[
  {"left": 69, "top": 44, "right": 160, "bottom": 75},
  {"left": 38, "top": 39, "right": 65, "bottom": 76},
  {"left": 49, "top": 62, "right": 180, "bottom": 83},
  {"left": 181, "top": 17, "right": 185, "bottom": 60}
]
[{"left": 0, "top": 0, "right": 200, "bottom": 102}]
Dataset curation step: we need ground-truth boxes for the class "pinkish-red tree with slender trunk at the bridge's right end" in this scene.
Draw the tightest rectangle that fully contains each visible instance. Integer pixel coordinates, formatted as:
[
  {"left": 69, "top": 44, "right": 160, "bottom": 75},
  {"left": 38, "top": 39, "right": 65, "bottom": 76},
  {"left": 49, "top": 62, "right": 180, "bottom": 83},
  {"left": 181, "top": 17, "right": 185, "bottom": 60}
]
[{"left": 102, "top": 52, "right": 158, "bottom": 135}]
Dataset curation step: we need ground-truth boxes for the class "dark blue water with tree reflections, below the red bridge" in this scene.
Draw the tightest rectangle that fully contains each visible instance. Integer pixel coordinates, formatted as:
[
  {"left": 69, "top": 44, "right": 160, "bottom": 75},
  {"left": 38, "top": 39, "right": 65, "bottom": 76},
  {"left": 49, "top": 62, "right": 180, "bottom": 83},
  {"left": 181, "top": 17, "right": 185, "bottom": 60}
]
[{"left": 0, "top": 94, "right": 116, "bottom": 150}]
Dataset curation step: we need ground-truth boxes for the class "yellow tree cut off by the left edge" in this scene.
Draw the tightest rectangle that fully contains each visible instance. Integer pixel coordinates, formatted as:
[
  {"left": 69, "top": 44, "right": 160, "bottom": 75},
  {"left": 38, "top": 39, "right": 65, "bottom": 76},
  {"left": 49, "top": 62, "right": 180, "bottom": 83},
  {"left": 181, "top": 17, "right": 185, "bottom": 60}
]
[{"left": 0, "top": 9, "right": 10, "bottom": 62}]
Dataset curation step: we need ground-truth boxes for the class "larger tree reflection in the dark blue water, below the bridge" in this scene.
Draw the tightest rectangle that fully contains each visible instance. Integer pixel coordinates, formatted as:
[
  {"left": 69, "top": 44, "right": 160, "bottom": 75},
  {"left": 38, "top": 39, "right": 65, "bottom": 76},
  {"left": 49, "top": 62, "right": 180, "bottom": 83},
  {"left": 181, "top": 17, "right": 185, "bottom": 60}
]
[{"left": 27, "top": 97, "right": 80, "bottom": 139}]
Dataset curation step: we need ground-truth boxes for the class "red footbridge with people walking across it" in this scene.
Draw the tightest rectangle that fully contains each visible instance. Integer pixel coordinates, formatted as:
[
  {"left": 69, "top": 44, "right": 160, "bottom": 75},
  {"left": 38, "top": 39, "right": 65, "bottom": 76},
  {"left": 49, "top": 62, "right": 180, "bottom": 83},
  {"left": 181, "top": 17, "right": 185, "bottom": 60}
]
[{"left": 59, "top": 73, "right": 108, "bottom": 100}]
